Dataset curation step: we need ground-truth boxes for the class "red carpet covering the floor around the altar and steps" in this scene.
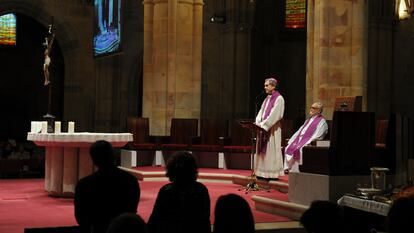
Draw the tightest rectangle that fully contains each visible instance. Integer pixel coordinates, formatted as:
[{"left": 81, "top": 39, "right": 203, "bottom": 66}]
[{"left": 0, "top": 175, "right": 290, "bottom": 233}]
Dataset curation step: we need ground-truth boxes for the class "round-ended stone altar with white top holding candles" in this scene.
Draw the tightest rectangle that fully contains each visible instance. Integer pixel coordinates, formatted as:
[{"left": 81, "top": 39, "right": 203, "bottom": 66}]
[{"left": 27, "top": 132, "right": 133, "bottom": 197}]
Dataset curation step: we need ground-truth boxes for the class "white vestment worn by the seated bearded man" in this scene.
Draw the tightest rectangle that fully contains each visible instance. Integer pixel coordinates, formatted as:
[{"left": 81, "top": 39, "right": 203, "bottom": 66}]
[{"left": 284, "top": 115, "right": 328, "bottom": 172}]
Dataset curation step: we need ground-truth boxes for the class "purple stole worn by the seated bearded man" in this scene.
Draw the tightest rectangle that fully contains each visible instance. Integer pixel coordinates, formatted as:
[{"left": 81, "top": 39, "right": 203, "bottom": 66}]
[{"left": 286, "top": 115, "right": 323, "bottom": 160}]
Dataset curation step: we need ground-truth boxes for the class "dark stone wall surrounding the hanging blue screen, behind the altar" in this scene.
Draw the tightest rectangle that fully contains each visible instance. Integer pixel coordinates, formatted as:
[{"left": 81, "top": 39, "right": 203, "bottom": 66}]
[{"left": 0, "top": 0, "right": 142, "bottom": 132}]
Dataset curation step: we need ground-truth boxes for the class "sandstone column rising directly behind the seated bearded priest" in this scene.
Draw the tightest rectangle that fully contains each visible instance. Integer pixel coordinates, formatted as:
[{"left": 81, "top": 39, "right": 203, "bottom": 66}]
[{"left": 306, "top": 0, "right": 368, "bottom": 119}]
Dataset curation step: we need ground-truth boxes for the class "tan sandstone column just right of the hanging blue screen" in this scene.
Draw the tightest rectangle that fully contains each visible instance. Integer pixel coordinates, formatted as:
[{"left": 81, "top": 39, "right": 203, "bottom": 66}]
[{"left": 142, "top": 0, "right": 203, "bottom": 135}]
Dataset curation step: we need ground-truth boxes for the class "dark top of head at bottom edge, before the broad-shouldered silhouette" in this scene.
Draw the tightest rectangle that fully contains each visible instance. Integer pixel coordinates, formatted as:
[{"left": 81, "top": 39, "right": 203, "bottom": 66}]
[{"left": 106, "top": 213, "right": 148, "bottom": 233}]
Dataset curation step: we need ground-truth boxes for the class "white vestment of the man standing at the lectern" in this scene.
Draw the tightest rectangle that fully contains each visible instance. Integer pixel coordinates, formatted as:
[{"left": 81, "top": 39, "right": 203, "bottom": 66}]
[{"left": 254, "top": 95, "right": 285, "bottom": 178}]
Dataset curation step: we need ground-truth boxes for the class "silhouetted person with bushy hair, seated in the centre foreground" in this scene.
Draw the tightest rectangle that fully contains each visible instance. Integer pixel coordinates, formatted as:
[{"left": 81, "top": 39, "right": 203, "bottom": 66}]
[{"left": 148, "top": 151, "right": 211, "bottom": 233}]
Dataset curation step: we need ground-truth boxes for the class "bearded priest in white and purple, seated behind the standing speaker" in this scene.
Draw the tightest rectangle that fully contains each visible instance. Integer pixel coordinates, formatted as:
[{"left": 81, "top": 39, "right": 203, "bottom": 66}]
[{"left": 284, "top": 102, "right": 328, "bottom": 174}]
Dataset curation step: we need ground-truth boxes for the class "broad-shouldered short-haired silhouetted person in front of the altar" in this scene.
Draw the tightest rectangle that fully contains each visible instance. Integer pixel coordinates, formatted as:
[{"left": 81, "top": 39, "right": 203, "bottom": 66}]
[{"left": 74, "top": 140, "right": 140, "bottom": 233}]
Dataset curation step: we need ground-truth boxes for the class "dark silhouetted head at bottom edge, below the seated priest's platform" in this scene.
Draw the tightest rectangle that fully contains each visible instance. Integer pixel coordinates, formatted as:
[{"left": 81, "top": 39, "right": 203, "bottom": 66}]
[{"left": 299, "top": 200, "right": 345, "bottom": 233}]
